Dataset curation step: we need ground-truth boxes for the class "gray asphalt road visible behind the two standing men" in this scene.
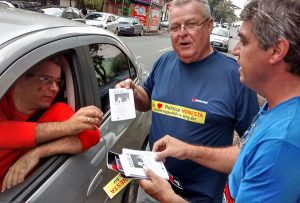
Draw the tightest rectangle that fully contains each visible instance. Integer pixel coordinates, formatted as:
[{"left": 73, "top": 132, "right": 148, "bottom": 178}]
[{"left": 120, "top": 26, "right": 238, "bottom": 70}]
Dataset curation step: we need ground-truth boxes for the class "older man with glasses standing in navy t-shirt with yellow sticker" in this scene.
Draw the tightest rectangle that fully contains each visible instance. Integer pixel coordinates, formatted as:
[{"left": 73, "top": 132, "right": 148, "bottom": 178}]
[{"left": 117, "top": 0, "right": 258, "bottom": 202}]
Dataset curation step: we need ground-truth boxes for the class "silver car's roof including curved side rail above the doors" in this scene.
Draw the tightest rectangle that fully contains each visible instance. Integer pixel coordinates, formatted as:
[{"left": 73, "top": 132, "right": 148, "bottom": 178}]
[{"left": 0, "top": 7, "right": 129, "bottom": 74}]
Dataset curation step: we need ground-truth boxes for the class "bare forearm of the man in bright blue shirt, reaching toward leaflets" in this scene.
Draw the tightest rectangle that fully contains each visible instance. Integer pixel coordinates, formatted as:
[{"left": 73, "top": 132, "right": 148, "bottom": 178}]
[{"left": 186, "top": 145, "right": 239, "bottom": 174}]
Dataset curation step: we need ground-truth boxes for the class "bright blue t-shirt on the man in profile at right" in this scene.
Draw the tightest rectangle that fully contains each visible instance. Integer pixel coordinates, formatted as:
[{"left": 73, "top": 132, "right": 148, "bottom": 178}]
[{"left": 229, "top": 97, "right": 300, "bottom": 203}]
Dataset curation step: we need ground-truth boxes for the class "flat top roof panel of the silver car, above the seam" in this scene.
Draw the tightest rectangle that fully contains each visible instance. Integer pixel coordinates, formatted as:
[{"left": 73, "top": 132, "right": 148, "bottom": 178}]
[{"left": 0, "top": 8, "right": 86, "bottom": 46}]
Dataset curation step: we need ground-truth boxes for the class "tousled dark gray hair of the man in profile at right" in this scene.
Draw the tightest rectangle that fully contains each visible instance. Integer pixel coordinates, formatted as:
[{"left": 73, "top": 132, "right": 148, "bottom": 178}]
[{"left": 240, "top": 0, "right": 300, "bottom": 75}]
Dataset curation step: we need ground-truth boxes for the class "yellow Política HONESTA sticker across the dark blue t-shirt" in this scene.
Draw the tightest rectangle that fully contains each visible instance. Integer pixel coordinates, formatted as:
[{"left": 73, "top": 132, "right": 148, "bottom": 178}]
[{"left": 152, "top": 100, "right": 206, "bottom": 124}]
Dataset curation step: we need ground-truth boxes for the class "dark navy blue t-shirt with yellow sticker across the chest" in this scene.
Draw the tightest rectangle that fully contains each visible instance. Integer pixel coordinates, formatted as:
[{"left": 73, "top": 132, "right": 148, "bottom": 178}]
[{"left": 144, "top": 51, "right": 258, "bottom": 202}]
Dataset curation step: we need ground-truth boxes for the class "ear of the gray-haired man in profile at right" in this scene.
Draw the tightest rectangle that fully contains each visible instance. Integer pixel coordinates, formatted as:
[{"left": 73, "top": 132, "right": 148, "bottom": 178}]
[{"left": 269, "top": 38, "right": 290, "bottom": 64}]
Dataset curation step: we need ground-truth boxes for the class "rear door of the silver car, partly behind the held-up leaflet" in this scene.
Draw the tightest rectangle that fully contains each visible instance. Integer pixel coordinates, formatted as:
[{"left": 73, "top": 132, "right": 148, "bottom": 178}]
[{"left": 81, "top": 37, "right": 150, "bottom": 202}]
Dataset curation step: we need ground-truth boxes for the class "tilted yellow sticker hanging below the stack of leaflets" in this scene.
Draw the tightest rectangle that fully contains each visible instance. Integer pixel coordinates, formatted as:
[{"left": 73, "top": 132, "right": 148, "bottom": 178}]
[{"left": 103, "top": 173, "right": 131, "bottom": 199}]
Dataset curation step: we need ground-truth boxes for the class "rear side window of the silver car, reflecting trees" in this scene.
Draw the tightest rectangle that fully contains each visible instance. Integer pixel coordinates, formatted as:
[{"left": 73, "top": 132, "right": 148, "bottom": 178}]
[{"left": 89, "top": 44, "right": 136, "bottom": 113}]
